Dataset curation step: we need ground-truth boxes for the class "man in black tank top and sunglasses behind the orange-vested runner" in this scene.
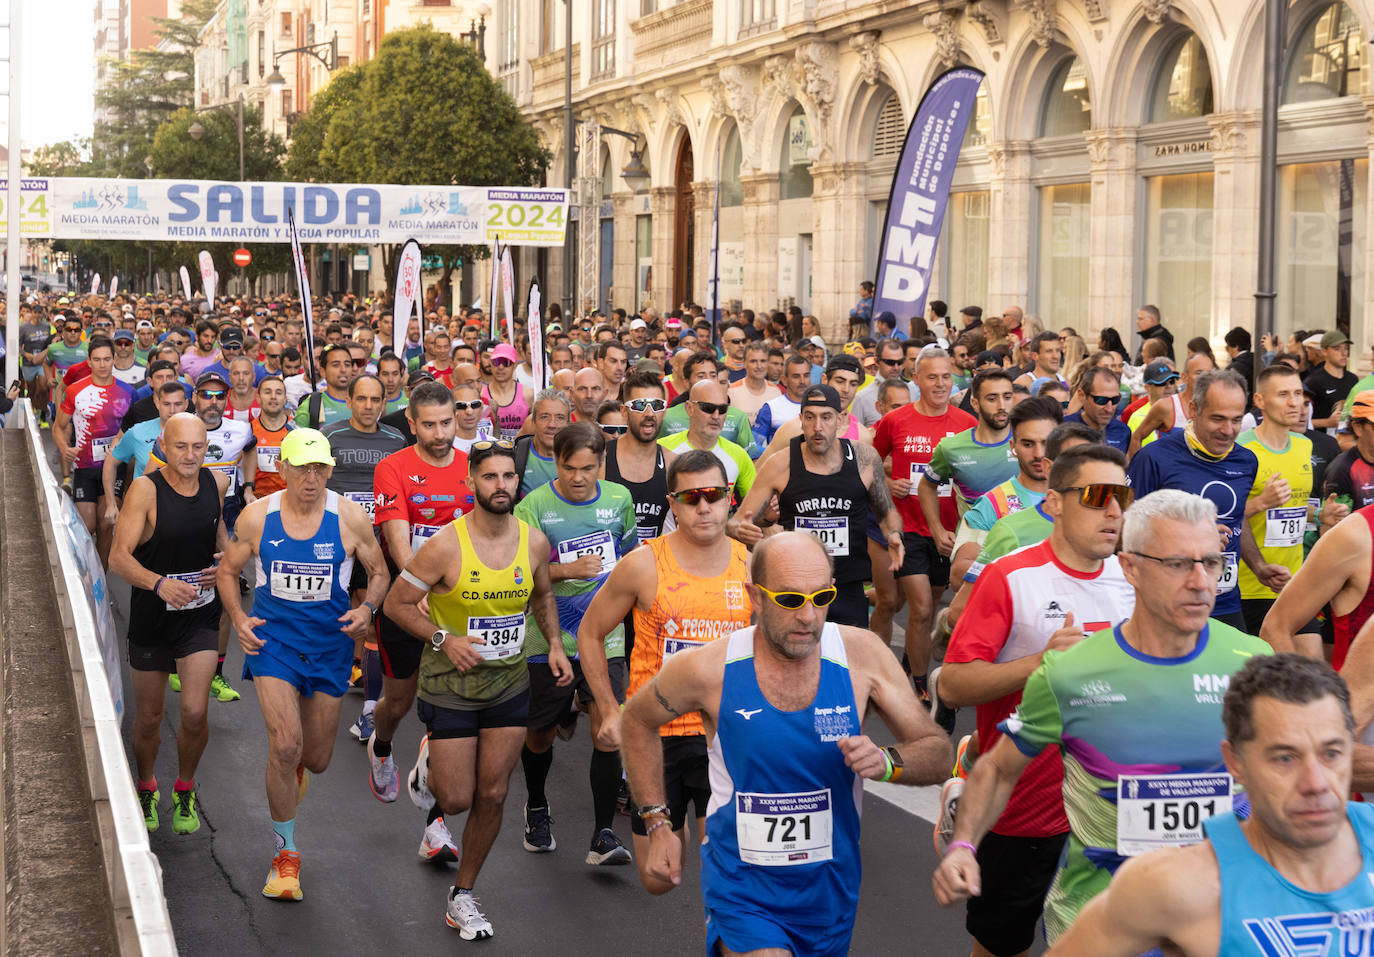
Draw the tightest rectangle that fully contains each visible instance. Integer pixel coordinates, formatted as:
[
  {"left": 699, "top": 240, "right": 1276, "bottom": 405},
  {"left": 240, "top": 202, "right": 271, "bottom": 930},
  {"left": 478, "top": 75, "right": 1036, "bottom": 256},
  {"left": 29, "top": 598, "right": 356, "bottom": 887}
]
[{"left": 603, "top": 369, "right": 677, "bottom": 542}]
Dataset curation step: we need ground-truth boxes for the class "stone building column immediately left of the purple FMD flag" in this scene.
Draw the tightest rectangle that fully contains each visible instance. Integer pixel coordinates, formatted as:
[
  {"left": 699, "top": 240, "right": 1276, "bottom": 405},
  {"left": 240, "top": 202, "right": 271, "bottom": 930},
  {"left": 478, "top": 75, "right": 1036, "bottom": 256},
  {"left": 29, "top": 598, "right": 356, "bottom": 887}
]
[{"left": 811, "top": 163, "right": 867, "bottom": 342}]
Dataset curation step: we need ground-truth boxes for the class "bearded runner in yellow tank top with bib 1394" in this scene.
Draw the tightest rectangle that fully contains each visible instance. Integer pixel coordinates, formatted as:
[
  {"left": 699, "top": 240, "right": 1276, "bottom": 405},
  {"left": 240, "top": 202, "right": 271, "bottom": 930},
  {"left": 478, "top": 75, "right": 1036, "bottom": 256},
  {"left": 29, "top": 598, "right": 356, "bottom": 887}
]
[{"left": 386, "top": 439, "right": 570, "bottom": 941}]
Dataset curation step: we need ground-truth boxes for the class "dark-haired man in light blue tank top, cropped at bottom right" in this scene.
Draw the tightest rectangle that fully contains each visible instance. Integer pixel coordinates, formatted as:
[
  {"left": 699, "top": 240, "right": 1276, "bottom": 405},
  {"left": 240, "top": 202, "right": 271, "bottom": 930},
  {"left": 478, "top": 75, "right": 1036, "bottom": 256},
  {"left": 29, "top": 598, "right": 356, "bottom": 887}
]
[{"left": 1050, "top": 655, "right": 1374, "bottom": 957}]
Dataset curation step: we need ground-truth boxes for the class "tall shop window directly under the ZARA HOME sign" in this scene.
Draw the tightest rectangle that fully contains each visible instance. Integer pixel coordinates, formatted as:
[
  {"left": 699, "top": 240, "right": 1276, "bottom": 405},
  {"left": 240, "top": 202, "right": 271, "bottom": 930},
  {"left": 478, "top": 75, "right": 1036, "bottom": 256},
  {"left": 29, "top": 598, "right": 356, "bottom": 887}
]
[{"left": 1145, "top": 173, "right": 1212, "bottom": 339}]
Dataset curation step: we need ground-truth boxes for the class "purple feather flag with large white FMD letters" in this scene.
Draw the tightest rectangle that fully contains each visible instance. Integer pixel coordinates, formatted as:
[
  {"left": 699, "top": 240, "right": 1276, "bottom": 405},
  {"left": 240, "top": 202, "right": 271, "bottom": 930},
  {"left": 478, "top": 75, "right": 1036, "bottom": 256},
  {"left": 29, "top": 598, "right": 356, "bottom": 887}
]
[{"left": 872, "top": 66, "right": 982, "bottom": 335}]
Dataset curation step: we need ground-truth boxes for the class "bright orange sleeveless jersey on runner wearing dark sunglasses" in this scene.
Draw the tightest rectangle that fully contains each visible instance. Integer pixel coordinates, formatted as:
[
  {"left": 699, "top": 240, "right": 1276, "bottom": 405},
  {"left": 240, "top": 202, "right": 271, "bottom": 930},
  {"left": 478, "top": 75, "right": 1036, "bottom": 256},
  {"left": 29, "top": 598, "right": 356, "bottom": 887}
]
[{"left": 628, "top": 537, "right": 750, "bottom": 737}]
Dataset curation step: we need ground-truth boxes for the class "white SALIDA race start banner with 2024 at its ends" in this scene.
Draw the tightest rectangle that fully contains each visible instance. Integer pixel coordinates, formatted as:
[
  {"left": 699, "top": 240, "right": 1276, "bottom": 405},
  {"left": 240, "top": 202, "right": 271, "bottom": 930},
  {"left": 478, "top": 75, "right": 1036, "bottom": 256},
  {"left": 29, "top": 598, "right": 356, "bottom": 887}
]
[{"left": 34, "top": 177, "right": 567, "bottom": 246}]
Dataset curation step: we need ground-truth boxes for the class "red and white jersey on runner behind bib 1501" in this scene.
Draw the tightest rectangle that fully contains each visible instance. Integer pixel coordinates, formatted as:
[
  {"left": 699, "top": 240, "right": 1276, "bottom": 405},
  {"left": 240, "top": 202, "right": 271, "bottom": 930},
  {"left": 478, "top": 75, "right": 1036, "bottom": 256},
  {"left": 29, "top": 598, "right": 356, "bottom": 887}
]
[{"left": 945, "top": 540, "right": 1135, "bottom": 838}]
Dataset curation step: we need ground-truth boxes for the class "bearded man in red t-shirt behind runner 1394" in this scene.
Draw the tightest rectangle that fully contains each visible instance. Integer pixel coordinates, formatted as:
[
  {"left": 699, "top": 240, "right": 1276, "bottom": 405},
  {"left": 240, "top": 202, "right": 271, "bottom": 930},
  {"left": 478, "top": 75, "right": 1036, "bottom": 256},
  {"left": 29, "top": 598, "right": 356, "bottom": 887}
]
[{"left": 367, "top": 382, "right": 474, "bottom": 834}]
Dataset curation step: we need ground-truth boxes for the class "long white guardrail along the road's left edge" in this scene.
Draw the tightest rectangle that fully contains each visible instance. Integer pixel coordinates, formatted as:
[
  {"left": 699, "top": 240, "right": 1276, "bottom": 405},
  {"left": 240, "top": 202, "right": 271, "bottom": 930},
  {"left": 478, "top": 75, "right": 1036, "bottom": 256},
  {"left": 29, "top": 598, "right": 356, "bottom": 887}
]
[{"left": 5, "top": 400, "right": 177, "bottom": 957}]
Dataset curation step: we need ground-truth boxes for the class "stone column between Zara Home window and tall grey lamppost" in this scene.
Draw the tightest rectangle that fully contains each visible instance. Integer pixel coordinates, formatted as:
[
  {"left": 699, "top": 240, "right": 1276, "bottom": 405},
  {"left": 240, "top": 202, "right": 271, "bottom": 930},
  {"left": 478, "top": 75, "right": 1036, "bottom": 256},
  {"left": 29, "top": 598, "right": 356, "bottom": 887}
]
[{"left": 1208, "top": 110, "right": 1260, "bottom": 347}]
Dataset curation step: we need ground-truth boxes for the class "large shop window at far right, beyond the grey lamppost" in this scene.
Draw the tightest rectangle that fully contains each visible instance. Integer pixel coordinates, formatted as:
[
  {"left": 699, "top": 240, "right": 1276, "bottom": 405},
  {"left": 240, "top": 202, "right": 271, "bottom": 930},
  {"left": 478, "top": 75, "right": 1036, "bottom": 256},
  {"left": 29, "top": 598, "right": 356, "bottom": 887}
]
[{"left": 1276, "top": 159, "right": 1369, "bottom": 342}]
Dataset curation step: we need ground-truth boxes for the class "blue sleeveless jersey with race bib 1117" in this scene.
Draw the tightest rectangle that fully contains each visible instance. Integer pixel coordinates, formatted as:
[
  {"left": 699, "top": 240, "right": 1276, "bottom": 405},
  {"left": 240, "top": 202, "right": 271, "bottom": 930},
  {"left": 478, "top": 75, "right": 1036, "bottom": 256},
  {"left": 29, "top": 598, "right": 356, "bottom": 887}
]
[{"left": 253, "top": 492, "right": 353, "bottom": 655}]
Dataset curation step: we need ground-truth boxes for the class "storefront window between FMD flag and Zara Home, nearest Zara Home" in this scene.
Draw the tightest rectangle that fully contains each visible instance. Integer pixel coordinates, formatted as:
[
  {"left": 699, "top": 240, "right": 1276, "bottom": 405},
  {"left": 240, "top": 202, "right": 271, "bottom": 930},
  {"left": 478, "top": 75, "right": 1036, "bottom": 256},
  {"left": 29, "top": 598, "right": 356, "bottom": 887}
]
[{"left": 1036, "top": 183, "right": 1092, "bottom": 328}]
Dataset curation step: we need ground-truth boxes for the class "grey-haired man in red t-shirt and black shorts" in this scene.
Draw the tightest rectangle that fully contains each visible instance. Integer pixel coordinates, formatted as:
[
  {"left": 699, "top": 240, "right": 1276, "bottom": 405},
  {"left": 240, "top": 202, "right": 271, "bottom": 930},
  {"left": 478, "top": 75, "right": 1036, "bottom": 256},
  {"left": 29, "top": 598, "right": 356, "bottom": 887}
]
[{"left": 872, "top": 346, "right": 978, "bottom": 689}]
